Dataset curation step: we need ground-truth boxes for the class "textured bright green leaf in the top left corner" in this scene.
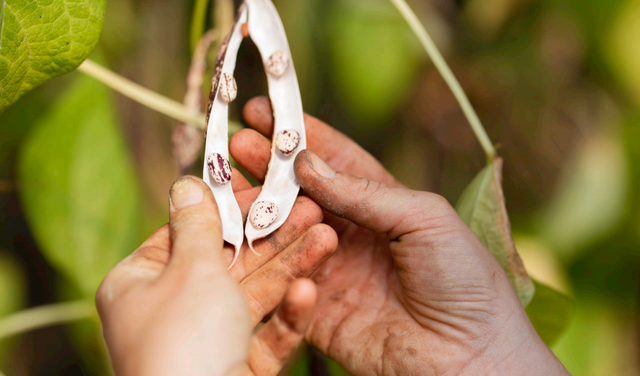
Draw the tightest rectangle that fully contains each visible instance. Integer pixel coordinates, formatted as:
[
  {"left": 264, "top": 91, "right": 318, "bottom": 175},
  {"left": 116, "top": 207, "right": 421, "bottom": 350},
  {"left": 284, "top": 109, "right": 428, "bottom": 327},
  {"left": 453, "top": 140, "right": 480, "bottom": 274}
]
[{"left": 0, "top": 0, "right": 105, "bottom": 112}]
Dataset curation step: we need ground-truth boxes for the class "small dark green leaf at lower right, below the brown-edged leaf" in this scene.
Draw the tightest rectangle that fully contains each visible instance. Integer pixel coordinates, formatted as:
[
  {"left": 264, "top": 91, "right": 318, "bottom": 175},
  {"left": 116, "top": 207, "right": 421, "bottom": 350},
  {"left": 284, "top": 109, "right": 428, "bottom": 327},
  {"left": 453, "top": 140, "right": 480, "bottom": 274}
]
[{"left": 526, "top": 280, "right": 573, "bottom": 346}]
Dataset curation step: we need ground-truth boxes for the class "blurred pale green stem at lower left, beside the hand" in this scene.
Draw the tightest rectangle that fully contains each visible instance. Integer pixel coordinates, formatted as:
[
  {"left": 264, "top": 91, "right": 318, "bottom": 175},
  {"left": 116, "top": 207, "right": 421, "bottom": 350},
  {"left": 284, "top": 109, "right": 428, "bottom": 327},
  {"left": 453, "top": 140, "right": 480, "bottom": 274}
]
[{"left": 0, "top": 300, "right": 96, "bottom": 339}]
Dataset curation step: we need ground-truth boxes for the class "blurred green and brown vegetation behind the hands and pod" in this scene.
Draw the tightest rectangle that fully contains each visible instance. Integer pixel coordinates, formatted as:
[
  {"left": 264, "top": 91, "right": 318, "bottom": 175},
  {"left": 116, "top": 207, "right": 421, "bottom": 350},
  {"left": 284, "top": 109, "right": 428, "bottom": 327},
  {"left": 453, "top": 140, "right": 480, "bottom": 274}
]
[{"left": 0, "top": 0, "right": 640, "bottom": 376}]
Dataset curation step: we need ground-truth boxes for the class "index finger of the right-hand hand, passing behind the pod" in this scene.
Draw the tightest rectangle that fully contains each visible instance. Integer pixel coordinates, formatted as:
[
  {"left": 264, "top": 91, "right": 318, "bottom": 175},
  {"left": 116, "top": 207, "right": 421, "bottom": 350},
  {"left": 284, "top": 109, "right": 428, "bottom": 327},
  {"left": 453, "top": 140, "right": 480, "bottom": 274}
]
[{"left": 242, "top": 97, "right": 400, "bottom": 185}]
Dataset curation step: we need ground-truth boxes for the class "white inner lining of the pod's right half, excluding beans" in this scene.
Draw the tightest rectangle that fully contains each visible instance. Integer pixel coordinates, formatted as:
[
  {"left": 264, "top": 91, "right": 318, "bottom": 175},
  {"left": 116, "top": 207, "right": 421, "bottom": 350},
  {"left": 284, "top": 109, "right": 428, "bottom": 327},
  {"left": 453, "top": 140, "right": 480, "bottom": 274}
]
[{"left": 245, "top": 0, "right": 307, "bottom": 253}]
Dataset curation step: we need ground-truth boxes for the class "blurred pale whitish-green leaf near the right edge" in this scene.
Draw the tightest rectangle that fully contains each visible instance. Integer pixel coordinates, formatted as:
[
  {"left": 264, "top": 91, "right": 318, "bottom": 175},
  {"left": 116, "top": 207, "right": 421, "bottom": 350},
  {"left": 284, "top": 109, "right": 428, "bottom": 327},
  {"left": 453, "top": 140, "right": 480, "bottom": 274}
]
[{"left": 539, "top": 129, "right": 630, "bottom": 262}]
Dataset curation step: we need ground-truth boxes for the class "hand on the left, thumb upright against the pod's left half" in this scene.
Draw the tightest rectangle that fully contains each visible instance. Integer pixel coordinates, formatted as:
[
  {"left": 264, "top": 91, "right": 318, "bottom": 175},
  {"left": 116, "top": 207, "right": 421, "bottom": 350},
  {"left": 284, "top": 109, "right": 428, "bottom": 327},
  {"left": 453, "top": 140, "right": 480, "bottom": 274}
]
[{"left": 96, "top": 176, "right": 336, "bottom": 376}]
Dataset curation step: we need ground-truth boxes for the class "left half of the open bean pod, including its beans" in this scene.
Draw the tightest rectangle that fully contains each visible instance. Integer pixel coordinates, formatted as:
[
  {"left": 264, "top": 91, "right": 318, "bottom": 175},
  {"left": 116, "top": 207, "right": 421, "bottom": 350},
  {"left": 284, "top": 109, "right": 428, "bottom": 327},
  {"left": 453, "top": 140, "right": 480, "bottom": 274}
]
[{"left": 202, "top": 5, "right": 247, "bottom": 267}]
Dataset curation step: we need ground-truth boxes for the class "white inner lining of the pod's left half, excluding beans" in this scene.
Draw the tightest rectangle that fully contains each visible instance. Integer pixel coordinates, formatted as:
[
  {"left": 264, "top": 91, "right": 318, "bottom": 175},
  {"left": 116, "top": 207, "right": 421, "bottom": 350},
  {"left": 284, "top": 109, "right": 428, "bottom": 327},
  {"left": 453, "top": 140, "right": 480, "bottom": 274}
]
[{"left": 202, "top": 5, "right": 247, "bottom": 268}]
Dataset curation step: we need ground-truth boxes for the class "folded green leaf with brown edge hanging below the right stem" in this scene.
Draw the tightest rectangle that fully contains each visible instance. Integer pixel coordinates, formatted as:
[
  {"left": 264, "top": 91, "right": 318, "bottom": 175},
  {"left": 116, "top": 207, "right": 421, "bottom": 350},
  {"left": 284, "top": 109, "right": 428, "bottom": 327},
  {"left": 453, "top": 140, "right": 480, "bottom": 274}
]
[{"left": 456, "top": 158, "right": 535, "bottom": 307}]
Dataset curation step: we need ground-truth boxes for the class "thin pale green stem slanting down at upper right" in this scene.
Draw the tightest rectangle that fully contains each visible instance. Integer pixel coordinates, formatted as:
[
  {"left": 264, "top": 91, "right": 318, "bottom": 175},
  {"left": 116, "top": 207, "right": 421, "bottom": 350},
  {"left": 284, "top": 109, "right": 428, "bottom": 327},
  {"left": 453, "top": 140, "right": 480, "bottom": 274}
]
[{"left": 391, "top": 0, "right": 496, "bottom": 162}]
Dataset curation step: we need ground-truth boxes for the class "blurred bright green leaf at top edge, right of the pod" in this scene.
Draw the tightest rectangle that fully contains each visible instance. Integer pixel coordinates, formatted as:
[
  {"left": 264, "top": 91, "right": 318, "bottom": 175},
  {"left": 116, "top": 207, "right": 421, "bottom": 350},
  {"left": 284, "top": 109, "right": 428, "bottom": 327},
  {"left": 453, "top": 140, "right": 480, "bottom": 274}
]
[{"left": 326, "top": 0, "right": 422, "bottom": 126}]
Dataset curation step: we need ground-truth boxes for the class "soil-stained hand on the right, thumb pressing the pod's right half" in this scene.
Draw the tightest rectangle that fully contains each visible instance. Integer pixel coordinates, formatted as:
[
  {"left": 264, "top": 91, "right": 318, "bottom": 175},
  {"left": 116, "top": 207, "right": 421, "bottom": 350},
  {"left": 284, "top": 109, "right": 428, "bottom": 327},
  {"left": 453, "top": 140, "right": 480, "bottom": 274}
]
[{"left": 230, "top": 98, "right": 567, "bottom": 375}]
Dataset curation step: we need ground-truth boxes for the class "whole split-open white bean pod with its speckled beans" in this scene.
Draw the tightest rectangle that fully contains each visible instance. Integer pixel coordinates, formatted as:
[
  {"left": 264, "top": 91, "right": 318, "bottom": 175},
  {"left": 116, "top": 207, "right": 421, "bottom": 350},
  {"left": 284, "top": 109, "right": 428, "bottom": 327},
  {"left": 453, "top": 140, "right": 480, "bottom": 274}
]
[{"left": 203, "top": 0, "right": 306, "bottom": 267}]
